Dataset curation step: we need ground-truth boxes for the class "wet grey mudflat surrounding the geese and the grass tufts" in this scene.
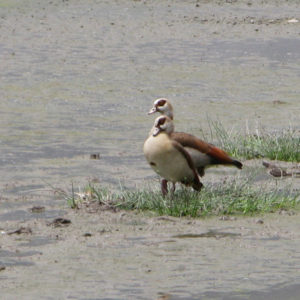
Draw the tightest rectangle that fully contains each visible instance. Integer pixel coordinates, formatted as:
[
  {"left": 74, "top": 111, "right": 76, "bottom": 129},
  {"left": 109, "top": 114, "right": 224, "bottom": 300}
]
[{"left": 0, "top": 0, "right": 300, "bottom": 300}]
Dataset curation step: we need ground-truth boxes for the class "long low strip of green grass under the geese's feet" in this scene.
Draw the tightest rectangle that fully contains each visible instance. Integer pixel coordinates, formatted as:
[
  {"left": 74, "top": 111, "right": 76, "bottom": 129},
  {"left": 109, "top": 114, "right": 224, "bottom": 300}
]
[{"left": 64, "top": 178, "right": 300, "bottom": 217}]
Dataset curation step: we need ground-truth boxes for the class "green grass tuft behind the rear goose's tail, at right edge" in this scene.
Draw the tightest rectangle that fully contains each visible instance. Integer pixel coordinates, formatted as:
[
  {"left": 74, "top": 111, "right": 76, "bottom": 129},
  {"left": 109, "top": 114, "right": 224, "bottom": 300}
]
[{"left": 209, "top": 121, "right": 300, "bottom": 162}]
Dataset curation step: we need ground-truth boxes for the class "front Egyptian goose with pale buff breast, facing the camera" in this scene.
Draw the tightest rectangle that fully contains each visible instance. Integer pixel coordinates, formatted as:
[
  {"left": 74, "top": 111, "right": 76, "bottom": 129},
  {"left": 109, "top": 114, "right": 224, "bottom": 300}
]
[{"left": 143, "top": 116, "right": 202, "bottom": 196}]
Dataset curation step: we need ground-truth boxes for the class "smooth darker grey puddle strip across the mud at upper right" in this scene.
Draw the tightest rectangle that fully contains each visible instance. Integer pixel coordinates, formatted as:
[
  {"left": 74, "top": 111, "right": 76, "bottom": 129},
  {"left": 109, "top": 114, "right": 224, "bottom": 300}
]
[{"left": 139, "top": 38, "right": 300, "bottom": 66}]
